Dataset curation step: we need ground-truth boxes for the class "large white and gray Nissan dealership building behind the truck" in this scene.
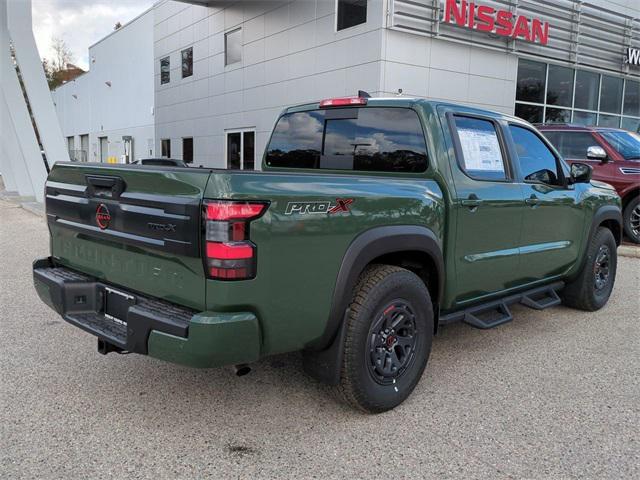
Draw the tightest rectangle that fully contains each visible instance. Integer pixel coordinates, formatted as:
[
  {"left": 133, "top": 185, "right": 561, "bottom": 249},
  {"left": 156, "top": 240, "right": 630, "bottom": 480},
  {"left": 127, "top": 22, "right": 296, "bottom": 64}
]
[{"left": 54, "top": 0, "right": 640, "bottom": 169}]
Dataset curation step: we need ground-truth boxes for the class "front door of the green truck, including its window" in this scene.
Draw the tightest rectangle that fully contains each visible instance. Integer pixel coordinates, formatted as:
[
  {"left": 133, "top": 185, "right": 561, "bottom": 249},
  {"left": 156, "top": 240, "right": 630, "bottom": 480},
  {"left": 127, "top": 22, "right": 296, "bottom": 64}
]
[{"left": 508, "top": 123, "right": 585, "bottom": 283}]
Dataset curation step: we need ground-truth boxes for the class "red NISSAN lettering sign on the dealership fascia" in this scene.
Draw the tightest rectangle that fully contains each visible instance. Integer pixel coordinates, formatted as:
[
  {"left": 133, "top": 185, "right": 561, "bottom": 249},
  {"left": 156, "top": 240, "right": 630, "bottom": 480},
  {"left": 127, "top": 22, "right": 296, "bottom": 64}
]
[{"left": 444, "top": 0, "right": 549, "bottom": 45}]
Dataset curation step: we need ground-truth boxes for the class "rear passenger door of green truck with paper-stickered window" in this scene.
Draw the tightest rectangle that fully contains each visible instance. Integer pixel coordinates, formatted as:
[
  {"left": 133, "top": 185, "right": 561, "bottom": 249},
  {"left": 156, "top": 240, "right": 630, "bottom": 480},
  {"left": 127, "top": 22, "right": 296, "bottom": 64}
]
[{"left": 448, "top": 113, "right": 524, "bottom": 307}]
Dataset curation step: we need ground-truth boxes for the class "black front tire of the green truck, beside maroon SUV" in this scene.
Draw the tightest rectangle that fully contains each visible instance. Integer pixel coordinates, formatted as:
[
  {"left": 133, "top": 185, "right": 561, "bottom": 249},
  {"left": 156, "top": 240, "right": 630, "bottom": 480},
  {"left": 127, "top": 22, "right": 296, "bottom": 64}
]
[{"left": 561, "top": 227, "right": 617, "bottom": 312}]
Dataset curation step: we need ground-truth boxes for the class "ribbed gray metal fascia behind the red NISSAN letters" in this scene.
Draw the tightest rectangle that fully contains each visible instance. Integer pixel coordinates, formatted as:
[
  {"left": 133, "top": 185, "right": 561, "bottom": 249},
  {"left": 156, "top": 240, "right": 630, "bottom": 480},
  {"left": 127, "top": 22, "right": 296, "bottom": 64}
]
[{"left": 389, "top": 0, "right": 640, "bottom": 77}]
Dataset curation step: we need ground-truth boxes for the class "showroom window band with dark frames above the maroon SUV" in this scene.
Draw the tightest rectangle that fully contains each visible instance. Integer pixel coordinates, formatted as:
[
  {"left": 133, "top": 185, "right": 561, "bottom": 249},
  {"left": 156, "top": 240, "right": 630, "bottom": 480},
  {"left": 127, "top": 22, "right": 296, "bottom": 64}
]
[{"left": 515, "top": 59, "right": 640, "bottom": 131}]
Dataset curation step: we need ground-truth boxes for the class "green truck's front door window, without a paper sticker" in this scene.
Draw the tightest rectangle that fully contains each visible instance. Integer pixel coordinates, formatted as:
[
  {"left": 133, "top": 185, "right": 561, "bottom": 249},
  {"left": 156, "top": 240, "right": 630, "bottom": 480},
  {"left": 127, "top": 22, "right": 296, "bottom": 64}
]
[{"left": 509, "top": 125, "right": 561, "bottom": 185}]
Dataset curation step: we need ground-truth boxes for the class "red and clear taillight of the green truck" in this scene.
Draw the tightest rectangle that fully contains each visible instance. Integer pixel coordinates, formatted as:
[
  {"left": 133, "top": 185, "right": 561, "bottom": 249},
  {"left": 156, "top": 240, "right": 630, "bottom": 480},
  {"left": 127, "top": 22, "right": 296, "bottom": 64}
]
[{"left": 203, "top": 200, "right": 268, "bottom": 280}]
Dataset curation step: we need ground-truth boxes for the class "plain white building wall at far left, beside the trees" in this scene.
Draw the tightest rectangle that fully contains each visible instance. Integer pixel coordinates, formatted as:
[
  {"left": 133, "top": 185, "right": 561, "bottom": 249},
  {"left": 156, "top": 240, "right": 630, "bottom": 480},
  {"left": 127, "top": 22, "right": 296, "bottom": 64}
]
[{"left": 52, "top": 10, "right": 155, "bottom": 161}]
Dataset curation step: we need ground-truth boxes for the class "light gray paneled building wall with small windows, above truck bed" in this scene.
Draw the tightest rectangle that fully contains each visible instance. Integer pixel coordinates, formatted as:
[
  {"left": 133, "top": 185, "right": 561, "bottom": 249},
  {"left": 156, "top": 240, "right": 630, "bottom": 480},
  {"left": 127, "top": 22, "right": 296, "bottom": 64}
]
[{"left": 154, "top": 0, "right": 385, "bottom": 167}]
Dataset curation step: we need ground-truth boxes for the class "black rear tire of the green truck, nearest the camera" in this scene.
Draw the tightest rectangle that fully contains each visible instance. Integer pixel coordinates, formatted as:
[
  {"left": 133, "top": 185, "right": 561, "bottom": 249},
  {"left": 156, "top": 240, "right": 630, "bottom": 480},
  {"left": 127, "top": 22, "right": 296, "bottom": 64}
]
[{"left": 335, "top": 265, "right": 433, "bottom": 413}]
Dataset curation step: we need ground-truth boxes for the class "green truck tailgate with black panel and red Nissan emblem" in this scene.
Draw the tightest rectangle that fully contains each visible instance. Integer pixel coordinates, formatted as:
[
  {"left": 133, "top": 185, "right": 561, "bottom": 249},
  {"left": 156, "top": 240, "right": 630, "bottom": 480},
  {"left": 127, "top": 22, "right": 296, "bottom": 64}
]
[{"left": 46, "top": 163, "right": 210, "bottom": 309}]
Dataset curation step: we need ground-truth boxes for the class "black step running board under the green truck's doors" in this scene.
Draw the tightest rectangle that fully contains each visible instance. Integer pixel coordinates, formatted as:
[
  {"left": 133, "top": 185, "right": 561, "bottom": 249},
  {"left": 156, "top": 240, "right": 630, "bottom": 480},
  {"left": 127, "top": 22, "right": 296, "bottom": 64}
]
[{"left": 438, "top": 282, "right": 564, "bottom": 329}]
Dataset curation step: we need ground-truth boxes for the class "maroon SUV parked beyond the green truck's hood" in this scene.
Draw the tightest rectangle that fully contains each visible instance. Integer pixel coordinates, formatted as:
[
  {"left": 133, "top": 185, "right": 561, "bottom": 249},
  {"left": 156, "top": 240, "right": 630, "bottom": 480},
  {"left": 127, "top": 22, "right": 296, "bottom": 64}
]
[{"left": 538, "top": 124, "right": 640, "bottom": 243}]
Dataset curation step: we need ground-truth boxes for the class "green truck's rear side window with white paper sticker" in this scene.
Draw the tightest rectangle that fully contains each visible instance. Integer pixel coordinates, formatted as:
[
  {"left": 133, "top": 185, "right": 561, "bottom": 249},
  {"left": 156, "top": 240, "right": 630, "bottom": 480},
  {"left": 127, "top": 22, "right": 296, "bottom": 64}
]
[{"left": 454, "top": 115, "right": 507, "bottom": 181}]
